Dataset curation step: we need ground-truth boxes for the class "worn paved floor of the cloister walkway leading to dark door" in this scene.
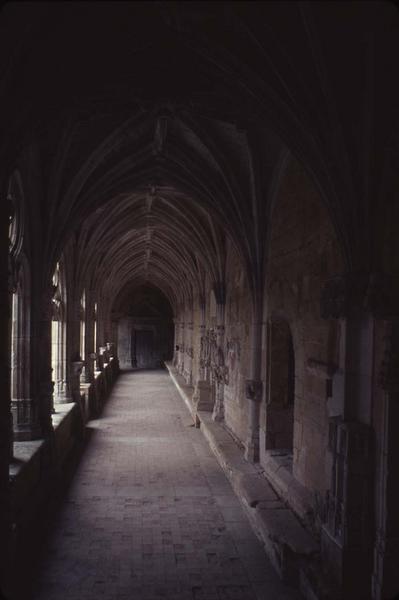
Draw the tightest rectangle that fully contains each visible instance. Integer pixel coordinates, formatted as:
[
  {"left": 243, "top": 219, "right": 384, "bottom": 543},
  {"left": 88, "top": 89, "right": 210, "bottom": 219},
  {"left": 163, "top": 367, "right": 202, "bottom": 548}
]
[{"left": 33, "top": 371, "right": 299, "bottom": 600}]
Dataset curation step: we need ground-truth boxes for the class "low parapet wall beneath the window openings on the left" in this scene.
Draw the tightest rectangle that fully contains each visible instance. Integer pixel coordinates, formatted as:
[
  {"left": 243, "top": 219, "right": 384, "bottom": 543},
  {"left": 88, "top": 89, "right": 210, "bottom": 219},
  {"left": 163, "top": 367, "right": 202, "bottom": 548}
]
[{"left": 6, "top": 359, "right": 119, "bottom": 599}]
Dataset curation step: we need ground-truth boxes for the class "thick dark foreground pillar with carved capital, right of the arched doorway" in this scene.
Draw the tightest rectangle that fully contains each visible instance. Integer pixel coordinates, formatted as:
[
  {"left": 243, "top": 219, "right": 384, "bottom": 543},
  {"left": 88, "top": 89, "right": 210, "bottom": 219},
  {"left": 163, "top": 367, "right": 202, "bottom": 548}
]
[{"left": 321, "top": 273, "right": 380, "bottom": 600}]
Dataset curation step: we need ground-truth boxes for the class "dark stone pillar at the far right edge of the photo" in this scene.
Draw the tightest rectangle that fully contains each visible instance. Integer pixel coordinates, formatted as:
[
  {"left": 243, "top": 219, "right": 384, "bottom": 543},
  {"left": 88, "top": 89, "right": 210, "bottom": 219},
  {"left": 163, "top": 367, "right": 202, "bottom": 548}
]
[{"left": 373, "top": 319, "right": 399, "bottom": 600}]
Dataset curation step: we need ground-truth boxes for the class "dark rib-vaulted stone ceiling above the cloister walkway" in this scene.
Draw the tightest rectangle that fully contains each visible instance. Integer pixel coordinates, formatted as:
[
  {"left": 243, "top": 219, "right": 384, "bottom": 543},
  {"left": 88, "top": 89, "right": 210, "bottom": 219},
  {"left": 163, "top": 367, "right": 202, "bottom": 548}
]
[{"left": 0, "top": 2, "right": 399, "bottom": 306}]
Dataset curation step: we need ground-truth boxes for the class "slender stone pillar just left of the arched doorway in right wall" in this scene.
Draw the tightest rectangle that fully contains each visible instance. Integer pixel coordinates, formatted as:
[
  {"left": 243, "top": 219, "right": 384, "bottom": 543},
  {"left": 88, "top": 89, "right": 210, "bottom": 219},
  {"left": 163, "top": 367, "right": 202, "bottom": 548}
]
[{"left": 245, "top": 292, "right": 262, "bottom": 462}]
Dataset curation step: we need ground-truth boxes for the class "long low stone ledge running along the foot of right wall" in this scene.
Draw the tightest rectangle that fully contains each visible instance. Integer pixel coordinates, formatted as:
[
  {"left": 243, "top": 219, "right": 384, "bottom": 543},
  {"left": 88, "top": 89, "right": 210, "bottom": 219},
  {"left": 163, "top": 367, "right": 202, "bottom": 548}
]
[{"left": 165, "top": 363, "right": 319, "bottom": 600}]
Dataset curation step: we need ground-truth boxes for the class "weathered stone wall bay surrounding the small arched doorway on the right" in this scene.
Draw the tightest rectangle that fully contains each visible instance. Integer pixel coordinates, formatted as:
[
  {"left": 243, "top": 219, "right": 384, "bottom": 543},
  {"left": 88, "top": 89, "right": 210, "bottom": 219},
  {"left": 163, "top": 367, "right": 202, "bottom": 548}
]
[{"left": 261, "top": 160, "right": 343, "bottom": 493}]
